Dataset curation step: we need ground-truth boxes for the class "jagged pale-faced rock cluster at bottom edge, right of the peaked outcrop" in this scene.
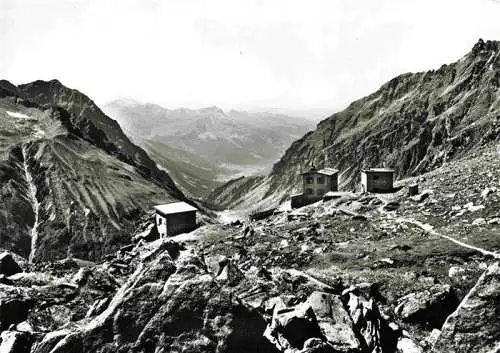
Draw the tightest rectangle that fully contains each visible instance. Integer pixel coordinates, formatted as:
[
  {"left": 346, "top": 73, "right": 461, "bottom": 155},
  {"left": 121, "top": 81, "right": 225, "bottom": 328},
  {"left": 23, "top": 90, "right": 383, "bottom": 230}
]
[{"left": 264, "top": 291, "right": 400, "bottom": 353}]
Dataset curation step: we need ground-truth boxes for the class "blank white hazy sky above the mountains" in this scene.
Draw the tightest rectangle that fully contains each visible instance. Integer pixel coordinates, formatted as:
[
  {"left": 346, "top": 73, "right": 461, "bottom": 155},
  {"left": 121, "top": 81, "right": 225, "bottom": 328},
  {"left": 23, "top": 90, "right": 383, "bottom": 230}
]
[{"left": 0, "top": 0, "right": 500, "bottom": 118}]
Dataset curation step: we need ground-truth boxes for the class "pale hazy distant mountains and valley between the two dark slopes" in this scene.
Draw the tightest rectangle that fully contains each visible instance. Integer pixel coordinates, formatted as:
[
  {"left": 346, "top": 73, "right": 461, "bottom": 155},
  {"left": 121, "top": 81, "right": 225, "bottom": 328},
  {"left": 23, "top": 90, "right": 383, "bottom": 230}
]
[{"left": 103, "top": 100, "right": 314, "bottom": 197}]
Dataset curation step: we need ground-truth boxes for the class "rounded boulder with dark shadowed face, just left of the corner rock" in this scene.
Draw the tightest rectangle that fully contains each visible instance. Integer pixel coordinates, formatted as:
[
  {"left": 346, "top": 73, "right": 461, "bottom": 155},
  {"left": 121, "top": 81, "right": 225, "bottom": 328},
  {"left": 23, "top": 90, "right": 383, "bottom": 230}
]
[{"left": 395, "top": 284, "right": 459, "bottom": 328}]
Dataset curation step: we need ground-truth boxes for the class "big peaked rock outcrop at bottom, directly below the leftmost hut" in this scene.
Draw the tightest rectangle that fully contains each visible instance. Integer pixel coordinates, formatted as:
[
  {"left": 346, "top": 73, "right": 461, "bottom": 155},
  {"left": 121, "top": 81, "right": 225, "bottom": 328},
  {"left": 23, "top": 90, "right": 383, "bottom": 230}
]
[{"left": 18, "top": 242, "right": 270, "bottom": 353}]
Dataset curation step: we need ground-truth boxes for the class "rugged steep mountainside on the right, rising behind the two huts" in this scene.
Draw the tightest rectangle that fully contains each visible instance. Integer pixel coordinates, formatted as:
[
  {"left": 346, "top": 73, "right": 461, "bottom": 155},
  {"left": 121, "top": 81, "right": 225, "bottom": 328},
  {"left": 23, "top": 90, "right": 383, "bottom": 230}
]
[{"left": 210, "top": 40, "right": 500, "bottom": 209}]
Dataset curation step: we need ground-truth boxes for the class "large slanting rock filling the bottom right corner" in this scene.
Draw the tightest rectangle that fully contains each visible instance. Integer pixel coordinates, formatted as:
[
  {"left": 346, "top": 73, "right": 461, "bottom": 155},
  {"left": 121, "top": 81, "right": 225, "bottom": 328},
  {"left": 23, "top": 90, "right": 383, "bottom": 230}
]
[{"left": 434, "top": 263, "right": 500, "bottom": 353}]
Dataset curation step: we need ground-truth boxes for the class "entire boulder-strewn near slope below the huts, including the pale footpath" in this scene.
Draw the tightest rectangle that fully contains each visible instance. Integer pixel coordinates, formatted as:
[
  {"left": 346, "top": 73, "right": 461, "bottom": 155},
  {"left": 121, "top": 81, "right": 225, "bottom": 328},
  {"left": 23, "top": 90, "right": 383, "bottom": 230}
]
[{"left": 0, "top": 145, "right": 500, "bottom": 353}]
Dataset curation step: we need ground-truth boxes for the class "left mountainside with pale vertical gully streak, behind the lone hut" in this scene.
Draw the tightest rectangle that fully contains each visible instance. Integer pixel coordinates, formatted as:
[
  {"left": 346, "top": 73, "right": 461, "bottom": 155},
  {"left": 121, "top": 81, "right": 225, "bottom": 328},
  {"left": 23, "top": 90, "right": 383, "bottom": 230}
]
[{"left": 0, "top": 81, "right": 184, "bottom": 261}]
